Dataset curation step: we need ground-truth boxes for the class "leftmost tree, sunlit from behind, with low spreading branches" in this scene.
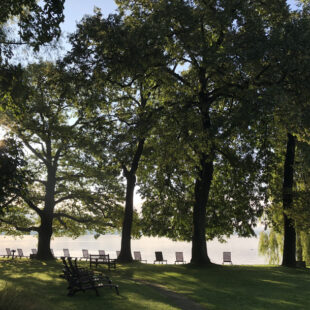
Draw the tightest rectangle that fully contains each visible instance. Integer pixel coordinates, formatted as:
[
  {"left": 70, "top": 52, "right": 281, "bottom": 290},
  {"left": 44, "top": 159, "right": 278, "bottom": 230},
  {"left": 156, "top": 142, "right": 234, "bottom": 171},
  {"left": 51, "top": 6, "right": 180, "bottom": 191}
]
[{"left": 0, "top": 63, "right": 122, "bottom": 259}]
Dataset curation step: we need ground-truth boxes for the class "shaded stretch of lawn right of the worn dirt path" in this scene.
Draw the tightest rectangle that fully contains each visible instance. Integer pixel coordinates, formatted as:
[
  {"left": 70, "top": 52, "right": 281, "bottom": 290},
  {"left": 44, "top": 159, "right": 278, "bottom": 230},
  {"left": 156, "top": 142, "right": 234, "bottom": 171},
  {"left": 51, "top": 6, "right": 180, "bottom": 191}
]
[{"left": 117, "top": 265, "right": 310, "bottom": 310}]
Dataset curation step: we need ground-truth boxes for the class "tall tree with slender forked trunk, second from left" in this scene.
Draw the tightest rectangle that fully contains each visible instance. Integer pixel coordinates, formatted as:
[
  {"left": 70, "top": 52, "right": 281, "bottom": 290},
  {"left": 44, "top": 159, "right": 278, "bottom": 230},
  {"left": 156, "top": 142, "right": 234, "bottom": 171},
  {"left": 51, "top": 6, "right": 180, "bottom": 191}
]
[{"left": 67, "top": 11, "right": 166, "bottom": 262}]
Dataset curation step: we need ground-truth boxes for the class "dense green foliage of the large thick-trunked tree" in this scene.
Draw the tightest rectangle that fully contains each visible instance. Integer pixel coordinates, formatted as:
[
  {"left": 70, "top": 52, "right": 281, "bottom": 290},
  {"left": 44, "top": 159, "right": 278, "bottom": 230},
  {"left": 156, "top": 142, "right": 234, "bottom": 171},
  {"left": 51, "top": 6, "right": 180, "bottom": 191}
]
[{"left": 112, "top": 1, "right": 294, "bottom": 246}]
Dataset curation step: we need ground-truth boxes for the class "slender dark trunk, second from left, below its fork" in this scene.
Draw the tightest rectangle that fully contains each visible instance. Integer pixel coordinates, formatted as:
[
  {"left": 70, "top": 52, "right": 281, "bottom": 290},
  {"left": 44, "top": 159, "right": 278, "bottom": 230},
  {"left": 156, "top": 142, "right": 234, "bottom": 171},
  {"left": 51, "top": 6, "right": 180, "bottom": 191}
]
[{"left": 118, "top": 172, "right": 136, "bottom": 263}]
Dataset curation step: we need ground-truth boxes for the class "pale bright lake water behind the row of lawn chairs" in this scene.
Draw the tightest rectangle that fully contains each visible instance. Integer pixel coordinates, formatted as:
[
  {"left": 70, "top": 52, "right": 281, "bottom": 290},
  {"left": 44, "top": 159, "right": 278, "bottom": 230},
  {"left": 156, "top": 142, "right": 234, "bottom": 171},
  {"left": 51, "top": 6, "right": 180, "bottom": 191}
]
[{"left": 0, "top": 235, "right": 266, "bottom": 265}]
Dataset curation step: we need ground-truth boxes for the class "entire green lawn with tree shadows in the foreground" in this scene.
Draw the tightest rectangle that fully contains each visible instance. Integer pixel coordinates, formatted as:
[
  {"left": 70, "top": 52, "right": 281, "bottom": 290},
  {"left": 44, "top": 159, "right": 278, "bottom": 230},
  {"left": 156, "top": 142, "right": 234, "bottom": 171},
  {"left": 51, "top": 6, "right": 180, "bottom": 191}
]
[{"left": 0, "top": 259, "right": 310, "bottom": 310}]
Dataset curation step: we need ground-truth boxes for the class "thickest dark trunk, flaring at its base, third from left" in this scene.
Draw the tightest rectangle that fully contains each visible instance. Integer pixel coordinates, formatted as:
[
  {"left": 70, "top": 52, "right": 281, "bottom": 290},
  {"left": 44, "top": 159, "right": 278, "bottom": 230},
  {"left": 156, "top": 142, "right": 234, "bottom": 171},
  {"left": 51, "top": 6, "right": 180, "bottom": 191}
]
[{"left": 191, "top": 156, "right": 213, "bottom": 265}]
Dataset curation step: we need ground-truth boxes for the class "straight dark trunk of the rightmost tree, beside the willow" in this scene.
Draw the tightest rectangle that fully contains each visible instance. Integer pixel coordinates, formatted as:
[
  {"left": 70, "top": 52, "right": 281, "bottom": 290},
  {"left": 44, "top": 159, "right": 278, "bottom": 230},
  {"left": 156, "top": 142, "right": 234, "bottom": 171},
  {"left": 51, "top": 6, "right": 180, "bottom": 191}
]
[{"left": 282, "top": 133, "right": 296, "bottom": 267}]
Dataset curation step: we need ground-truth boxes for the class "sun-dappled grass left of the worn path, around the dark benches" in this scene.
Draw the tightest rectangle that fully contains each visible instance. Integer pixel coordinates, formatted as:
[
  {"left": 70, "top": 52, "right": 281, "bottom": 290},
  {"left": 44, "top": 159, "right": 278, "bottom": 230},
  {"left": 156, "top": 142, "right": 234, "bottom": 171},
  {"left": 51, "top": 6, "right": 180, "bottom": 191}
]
[{"left": 0, "top": 259, "right": 176, "bottom": 310}]
